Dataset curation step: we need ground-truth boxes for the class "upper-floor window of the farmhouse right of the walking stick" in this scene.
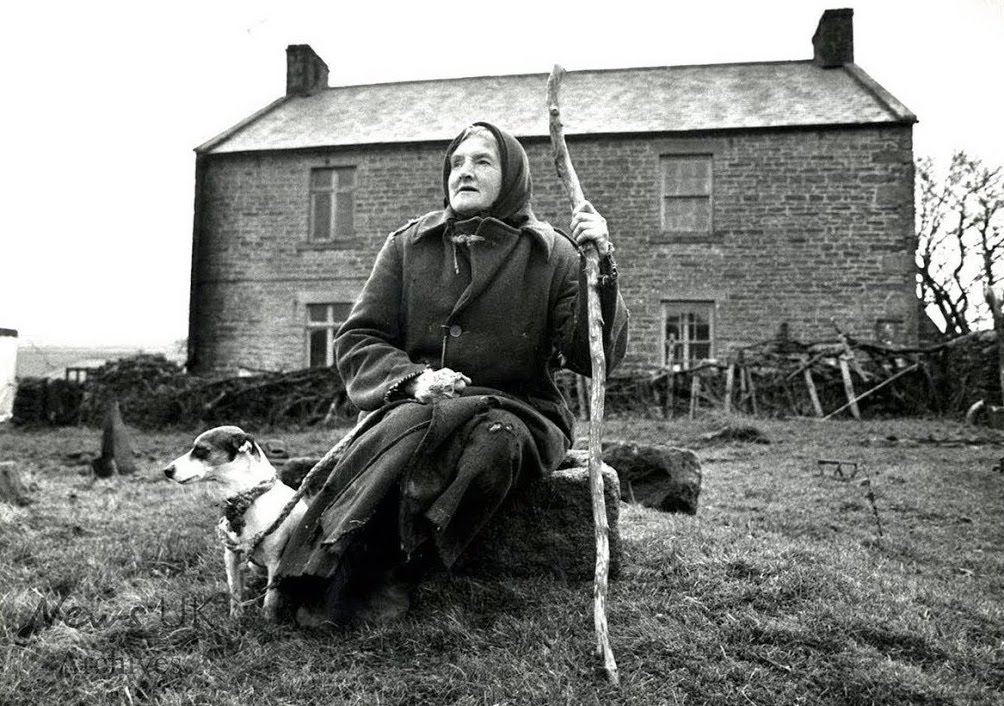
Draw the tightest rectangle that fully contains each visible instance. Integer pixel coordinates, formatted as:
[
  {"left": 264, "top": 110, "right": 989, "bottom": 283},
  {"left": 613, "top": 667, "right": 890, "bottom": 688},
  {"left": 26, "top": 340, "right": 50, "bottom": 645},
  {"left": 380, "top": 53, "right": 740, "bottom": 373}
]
[{"left": 661, "top": 155, "right": 712, "bottom": 236}]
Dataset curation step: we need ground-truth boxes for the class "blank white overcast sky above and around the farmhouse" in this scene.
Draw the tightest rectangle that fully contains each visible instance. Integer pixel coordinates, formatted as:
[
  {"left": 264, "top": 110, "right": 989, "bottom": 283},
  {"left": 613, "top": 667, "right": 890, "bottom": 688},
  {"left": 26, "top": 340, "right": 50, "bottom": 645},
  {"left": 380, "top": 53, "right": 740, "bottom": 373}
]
[{"left": 0, "top": 0, "right": 1004, "bottom": 347}]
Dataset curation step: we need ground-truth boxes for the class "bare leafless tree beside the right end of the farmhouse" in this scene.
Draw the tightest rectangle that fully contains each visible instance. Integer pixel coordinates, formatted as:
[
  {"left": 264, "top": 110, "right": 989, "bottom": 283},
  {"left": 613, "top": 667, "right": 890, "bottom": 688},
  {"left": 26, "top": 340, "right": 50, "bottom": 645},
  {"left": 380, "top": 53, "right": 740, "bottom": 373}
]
[{"left": 917, "top": 152, "right": 1004, "bottom": 335}]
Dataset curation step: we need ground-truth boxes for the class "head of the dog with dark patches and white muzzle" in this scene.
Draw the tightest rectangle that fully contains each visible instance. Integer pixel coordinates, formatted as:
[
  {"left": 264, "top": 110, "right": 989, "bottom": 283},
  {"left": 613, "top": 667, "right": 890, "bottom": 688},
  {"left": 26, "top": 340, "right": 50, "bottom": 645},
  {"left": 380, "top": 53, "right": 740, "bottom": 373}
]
[{"left": 164, "top": 427, "right": 275, "bottom": 486}]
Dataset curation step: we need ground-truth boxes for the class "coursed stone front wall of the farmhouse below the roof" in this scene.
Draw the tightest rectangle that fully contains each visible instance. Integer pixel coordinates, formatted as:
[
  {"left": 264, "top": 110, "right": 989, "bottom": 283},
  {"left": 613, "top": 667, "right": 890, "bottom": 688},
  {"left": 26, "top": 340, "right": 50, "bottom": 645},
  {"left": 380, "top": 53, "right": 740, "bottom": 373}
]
[{"left": 191, "top": 126, "right": 918, "bottom": 373}]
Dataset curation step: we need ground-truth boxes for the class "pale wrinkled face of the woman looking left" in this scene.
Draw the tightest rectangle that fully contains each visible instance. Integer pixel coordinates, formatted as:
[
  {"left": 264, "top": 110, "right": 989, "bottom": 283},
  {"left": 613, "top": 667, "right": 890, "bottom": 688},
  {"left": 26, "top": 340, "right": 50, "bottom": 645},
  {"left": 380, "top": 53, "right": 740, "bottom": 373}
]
[{"left": 448, "top": 131, "right": 502, "bottom": 216}]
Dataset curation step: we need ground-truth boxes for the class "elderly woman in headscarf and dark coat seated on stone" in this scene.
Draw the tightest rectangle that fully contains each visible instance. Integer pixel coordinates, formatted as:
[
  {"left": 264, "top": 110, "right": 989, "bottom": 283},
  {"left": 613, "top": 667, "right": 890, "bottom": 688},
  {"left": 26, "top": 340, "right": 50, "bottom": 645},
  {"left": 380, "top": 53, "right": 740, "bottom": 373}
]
[{"left": 280, "top": 123, "right": 626, "bottom": 622}]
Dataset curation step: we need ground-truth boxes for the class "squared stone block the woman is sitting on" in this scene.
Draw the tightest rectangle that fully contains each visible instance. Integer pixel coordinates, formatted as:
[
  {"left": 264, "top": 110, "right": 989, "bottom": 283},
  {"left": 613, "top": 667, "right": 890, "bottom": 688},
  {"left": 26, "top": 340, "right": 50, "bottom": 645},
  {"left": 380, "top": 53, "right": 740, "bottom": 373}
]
[{"left": 456, "top": 451, "right": 622, "bottom": 579}]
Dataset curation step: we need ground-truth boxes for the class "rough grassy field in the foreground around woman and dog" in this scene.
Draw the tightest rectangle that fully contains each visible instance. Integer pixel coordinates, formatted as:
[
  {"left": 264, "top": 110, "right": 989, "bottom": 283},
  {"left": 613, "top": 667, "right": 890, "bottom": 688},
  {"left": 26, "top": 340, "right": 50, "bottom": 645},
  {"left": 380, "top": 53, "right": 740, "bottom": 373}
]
[{"left": 0, "top": 418, "right": 1004, "bottom": 706}]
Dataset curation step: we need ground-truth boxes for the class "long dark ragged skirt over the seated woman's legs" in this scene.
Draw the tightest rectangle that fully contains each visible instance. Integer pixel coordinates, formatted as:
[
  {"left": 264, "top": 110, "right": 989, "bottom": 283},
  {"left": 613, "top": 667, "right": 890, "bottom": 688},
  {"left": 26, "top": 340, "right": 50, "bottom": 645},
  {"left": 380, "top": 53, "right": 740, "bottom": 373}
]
[{"left": 279, "top": 391, "right": 569, "bottom": 620}]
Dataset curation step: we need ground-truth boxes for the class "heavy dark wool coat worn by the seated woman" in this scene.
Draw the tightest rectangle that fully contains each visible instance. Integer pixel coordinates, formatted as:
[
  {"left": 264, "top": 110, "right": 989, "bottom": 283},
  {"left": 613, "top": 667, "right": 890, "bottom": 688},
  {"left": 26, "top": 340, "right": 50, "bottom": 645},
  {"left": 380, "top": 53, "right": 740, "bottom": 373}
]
[{"left": 335, "top": 211, "right": 628, "bottom": 439}]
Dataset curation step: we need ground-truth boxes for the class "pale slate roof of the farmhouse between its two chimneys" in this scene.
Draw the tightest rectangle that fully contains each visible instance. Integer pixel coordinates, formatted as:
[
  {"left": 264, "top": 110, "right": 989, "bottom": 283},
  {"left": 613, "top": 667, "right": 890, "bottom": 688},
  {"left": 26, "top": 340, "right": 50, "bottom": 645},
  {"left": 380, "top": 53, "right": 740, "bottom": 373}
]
[{"left": 197, "top": 60, "right": 917, "bottom": 154}]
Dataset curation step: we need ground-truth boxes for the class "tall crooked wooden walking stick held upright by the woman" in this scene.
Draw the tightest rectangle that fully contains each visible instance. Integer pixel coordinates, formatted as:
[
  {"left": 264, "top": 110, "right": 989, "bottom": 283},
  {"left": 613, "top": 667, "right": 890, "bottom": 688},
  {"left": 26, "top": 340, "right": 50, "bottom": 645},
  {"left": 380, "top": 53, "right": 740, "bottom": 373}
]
[{"left": 547, "top": 64, "right": 619, "bottom": 685}]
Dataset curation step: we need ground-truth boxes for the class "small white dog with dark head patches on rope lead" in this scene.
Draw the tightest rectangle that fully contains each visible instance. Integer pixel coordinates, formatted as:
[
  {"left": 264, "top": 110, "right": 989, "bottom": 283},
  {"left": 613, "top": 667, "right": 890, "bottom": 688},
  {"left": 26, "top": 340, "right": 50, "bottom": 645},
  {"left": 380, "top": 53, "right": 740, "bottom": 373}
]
[{"left": 164, "top": 427, "right": 307, "bottom": 621}]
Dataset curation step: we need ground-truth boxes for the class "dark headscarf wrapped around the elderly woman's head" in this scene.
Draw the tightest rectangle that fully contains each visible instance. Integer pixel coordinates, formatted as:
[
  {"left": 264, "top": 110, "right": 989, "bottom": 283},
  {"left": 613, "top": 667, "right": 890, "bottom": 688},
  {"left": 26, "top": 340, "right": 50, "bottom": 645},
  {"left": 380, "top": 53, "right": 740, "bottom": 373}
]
[{"left": 443, "top": 123, "right": 533, "bottom": 228}]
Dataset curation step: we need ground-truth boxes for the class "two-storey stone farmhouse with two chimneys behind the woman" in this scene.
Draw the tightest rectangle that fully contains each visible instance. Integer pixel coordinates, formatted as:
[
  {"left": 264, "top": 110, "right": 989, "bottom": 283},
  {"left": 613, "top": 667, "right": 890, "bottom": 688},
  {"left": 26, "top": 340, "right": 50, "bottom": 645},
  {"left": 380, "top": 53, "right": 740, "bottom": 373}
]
[{"left": 189, "top": 9, "right": 918, "bottom": 375}]
